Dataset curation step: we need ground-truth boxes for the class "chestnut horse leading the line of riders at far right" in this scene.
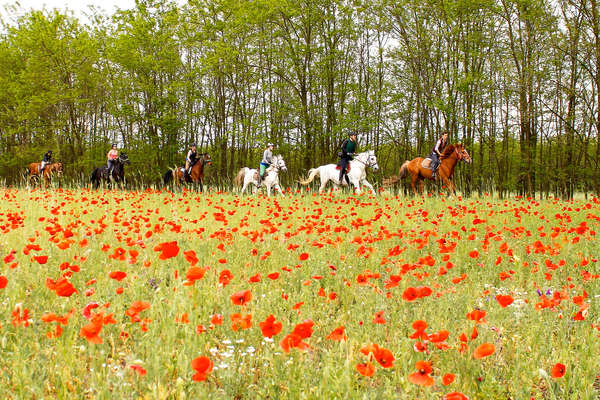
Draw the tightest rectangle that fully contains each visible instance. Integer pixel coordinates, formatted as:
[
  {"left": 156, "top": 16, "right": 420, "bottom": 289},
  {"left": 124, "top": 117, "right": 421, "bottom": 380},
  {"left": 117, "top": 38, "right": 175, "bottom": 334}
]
[{"left": 383, "top": 143, "right": 472, "bottom": 196}]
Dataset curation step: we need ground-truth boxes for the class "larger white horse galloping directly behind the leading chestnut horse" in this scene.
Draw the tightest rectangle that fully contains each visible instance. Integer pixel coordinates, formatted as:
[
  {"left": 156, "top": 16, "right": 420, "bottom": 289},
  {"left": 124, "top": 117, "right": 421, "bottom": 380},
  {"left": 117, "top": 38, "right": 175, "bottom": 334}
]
[{"left": 300, "top": 150, "right": 379, "bottom": 194}]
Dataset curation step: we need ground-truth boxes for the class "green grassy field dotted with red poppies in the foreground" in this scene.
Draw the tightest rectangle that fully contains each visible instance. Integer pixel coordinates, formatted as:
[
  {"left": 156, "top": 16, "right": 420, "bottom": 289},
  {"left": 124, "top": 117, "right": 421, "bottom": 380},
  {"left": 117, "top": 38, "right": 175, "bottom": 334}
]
[{"left": 0, "top": 189, "right": 600, "bottom": 400}]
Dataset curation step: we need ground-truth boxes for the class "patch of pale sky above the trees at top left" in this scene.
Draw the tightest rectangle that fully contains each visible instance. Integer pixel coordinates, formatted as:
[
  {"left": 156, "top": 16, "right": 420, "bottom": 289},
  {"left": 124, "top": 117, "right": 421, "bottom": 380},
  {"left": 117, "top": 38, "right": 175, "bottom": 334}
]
[{"left": 0, "top": 0, "right": 135, "bottom": 22}]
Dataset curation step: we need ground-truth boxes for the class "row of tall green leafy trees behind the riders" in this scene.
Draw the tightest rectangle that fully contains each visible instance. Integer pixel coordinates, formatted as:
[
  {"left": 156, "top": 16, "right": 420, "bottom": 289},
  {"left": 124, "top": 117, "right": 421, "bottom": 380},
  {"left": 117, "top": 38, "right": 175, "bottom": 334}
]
[{"left": 0, "top": 0, "right": 600, "bottom": 197}]
